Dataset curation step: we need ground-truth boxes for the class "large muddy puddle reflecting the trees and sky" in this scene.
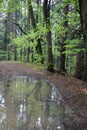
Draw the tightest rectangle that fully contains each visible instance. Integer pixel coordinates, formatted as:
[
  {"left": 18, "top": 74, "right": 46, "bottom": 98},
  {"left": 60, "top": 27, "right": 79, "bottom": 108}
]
[{"left": 0, "top": 77, "right": 74, "bottom": 130}]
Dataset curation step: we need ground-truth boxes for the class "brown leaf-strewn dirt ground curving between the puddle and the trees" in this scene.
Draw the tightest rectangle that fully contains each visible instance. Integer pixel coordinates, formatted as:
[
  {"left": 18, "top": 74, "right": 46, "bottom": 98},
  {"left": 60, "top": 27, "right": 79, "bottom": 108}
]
[{"left": 0, "top": 61, "right": 87, "bottom": 130}]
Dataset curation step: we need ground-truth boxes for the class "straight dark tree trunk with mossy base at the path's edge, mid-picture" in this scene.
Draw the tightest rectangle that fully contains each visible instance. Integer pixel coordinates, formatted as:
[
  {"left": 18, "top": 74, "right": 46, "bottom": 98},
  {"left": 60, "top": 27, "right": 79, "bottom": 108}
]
[{"left": 43, "top": 0, "right": 54, "bottom": 72}]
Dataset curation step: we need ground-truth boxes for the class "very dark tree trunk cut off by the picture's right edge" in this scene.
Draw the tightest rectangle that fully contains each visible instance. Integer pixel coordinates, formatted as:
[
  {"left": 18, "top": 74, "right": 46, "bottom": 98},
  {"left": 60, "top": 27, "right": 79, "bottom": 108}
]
[{"left": 78, "top": 0, "right": 87, "bottom": 81}]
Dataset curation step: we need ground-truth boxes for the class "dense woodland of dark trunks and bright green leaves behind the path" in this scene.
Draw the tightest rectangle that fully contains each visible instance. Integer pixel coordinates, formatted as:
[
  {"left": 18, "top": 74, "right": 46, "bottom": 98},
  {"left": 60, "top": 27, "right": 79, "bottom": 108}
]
[{"left": 0, "top": 0, "right": 87, "bottom": 81}]
